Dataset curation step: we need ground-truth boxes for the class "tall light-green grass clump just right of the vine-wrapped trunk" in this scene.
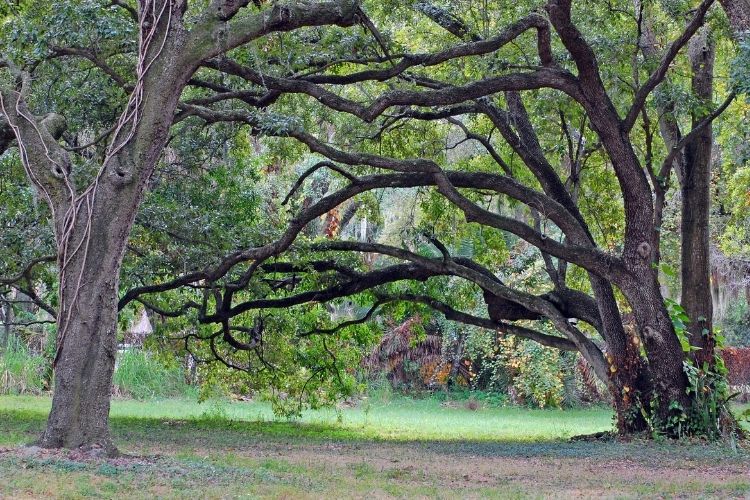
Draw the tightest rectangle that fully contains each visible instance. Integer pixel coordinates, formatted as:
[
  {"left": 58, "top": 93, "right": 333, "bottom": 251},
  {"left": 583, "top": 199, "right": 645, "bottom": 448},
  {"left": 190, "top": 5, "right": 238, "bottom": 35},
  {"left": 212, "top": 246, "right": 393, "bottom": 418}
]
[{"left": 113, "top": 350, "right": 192, "bottom": 399}]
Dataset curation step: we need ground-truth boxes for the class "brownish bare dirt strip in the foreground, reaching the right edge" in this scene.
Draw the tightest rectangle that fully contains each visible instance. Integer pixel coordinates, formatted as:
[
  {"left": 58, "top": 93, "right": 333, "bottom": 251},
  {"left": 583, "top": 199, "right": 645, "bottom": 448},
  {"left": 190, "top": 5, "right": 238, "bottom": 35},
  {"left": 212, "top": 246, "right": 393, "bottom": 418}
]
[{"left": 210, "top": 443, "right": 750, "bottom": 497}]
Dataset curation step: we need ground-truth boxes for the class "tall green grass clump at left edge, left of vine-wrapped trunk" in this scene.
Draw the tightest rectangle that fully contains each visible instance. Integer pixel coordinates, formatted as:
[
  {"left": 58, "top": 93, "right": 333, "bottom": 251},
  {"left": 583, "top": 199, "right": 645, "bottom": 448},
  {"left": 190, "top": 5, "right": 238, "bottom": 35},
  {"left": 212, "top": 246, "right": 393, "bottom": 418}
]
[{"left": 0, "top": 335, "right": 47, "bottom": 394}]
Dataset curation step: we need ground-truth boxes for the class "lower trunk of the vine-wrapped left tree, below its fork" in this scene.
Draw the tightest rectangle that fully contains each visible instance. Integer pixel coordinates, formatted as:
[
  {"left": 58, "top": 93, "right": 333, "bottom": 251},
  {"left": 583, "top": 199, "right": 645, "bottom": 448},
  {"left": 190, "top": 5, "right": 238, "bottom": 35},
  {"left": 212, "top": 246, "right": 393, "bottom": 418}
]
[{"left": 41, "top": 194, "right": 135, "bottom": 454}]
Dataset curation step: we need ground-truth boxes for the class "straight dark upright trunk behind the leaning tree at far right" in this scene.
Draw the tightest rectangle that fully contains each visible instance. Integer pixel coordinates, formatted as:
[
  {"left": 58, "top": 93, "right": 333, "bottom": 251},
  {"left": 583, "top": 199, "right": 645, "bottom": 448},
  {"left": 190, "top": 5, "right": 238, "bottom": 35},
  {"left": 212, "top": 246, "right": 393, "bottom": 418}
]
[{"left": 681, "top": 32, "right": 716, "bottom": 366}]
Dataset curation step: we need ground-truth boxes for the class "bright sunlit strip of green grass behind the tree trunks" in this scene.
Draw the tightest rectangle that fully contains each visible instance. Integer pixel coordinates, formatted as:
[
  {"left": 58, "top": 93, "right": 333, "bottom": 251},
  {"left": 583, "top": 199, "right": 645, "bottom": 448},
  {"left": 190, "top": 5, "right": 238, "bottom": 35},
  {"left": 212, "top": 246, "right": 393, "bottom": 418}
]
[{"left": 0, "top": 396, "right": 612, "bottom": 441}]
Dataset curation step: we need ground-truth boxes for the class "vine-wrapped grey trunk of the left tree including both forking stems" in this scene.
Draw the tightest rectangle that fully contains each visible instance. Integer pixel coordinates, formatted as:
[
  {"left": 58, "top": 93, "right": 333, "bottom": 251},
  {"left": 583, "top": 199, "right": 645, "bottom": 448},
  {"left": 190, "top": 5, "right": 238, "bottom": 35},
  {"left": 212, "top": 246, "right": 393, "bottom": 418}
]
[{"left": 0, "top": 3, "right": 197, "bottom": 454}]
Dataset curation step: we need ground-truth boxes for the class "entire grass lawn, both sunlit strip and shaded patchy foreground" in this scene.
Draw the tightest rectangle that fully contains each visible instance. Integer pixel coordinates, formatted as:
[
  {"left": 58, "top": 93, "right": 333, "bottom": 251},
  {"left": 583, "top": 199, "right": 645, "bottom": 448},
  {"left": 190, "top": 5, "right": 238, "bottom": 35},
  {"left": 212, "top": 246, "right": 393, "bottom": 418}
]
[{"left": 0, "top": 397, "right": 750, "bottom": 498}]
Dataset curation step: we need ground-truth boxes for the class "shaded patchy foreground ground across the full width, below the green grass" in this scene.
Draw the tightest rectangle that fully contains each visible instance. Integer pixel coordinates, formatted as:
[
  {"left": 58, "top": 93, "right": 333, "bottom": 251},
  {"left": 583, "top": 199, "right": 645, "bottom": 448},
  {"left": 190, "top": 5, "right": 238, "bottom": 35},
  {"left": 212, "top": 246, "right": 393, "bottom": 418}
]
[{"left": 0, "top": 439, "right": 750, "bottom": 498}]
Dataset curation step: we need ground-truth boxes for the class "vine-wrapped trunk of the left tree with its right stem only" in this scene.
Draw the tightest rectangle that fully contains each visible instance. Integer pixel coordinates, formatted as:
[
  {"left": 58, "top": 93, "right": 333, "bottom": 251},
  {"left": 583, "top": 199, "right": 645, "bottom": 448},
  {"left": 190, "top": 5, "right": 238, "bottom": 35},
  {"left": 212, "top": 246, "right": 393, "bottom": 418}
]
[{"left": 34, "top": 7, "right": 197, "bottom": 454}]
